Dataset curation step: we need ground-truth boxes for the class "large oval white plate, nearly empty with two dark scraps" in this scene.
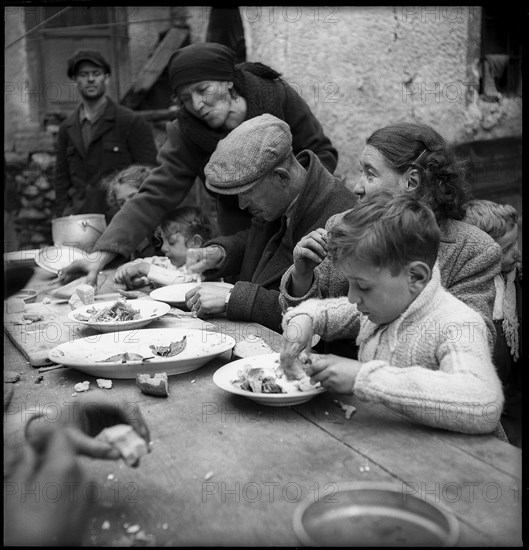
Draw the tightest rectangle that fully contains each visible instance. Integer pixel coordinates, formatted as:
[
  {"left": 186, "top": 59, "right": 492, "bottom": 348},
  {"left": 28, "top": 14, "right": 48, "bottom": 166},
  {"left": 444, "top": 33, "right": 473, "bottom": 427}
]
[{"left": 48, "top": 328, "right": 235, "bottom": 378}]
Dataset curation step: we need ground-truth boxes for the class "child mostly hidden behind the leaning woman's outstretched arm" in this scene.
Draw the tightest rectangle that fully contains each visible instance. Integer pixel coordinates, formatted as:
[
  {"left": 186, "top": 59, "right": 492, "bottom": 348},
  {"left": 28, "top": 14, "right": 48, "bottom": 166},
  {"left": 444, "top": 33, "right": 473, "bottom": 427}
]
[{"left": 101, "top": 164, "right": 160, "bottom": 259}]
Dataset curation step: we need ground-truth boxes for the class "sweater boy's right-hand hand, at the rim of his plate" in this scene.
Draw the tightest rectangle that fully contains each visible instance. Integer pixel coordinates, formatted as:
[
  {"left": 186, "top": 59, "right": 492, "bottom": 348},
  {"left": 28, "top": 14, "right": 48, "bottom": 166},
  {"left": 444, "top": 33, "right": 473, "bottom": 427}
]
[{"left": 305, "top": 354, "right": 362, "bottom": 394}]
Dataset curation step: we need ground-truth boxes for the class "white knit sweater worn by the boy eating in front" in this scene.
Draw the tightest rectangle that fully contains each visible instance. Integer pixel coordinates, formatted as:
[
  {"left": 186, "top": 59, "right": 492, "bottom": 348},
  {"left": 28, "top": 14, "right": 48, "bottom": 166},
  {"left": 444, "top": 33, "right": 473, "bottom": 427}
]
[{"left": 283, "top": 264, "right": 504, "bottom": 434}]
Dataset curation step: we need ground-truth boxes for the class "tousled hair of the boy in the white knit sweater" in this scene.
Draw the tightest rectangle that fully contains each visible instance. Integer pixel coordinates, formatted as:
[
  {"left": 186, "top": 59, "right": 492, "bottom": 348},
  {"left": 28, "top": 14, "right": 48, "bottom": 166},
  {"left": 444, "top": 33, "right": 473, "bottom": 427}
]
[{"left": 328, "top": 191, "right": 441, "bottom": 276}]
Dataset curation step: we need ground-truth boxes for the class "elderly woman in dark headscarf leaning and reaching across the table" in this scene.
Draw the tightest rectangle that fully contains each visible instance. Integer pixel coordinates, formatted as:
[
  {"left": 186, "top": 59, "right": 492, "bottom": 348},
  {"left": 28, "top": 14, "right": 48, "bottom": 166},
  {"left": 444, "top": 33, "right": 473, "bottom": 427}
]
[{"left": 58, "top": 43, "right": 338, "bottom": 284}]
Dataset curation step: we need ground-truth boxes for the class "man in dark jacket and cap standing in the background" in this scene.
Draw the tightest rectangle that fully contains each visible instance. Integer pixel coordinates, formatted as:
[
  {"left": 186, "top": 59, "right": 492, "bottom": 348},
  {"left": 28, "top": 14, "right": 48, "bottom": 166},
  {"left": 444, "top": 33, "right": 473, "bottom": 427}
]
[{"left": 53, "top": 50, "right": 157, "bottom": 218}]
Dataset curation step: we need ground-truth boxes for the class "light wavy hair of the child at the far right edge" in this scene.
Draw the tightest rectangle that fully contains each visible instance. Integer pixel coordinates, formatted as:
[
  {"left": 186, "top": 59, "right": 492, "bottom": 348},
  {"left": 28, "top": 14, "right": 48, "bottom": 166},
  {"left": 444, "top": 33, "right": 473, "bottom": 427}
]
[{"left": 463, "top": 199, "right": 518, "bottom": 240}]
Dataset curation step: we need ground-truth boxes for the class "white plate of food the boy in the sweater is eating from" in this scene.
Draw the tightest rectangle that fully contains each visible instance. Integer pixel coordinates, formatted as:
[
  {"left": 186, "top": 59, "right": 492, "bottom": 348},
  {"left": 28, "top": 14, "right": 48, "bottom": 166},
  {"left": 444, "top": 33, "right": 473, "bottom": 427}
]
[{"left": 213, "top": 353, "right": 325, "bottom": 407}]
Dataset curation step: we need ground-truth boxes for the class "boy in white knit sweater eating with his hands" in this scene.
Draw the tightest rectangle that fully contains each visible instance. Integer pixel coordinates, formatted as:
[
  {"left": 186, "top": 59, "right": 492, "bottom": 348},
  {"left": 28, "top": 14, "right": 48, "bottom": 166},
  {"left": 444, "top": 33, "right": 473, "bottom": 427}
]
[{"left": 281, "top": 191, "right": 503, "bottom": 434}]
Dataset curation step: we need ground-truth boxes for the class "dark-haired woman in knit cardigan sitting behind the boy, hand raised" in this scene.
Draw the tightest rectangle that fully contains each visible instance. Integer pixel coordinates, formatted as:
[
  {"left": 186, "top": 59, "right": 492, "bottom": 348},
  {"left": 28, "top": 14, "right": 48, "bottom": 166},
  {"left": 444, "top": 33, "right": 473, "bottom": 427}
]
[{"left": 279, "top": 122, "right": 501, "bottom": 345}]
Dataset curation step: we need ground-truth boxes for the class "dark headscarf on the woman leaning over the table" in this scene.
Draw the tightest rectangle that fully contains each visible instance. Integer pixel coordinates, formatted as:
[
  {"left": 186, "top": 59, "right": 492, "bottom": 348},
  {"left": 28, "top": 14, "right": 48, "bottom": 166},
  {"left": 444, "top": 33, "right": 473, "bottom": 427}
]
[{"left": 169, "top": 42, "right": 235, "bottom": 92}]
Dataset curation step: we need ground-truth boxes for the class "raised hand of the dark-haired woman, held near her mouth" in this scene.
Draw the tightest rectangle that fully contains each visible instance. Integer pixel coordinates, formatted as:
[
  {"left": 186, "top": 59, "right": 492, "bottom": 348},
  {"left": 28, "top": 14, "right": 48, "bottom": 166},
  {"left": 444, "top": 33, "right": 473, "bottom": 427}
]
[{"left": 291, "top": 227, "right": 327, "bottom": 296}]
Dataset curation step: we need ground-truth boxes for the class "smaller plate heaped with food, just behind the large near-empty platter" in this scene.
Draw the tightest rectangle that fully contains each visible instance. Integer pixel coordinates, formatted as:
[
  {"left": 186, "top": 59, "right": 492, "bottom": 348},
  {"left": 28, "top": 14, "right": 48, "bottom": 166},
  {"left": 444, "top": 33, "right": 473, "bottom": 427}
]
[{"left": 68, "top": 298, "right": 171, "bottom": 332}]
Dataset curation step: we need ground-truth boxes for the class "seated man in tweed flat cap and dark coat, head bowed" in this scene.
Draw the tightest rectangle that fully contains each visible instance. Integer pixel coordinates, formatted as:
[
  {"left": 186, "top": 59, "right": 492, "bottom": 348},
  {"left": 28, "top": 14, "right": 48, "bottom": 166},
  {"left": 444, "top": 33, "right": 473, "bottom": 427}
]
[{"left": 180, "top": 114, "right": 355, "bottom": 331}]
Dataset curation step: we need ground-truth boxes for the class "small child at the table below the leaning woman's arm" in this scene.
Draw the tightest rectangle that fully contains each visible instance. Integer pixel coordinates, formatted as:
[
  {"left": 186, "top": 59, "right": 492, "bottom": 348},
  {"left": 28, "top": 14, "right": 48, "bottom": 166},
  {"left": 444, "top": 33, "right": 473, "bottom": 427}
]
[{"left": 114, "top": 206, "right": 212, "bottom": 288}]
